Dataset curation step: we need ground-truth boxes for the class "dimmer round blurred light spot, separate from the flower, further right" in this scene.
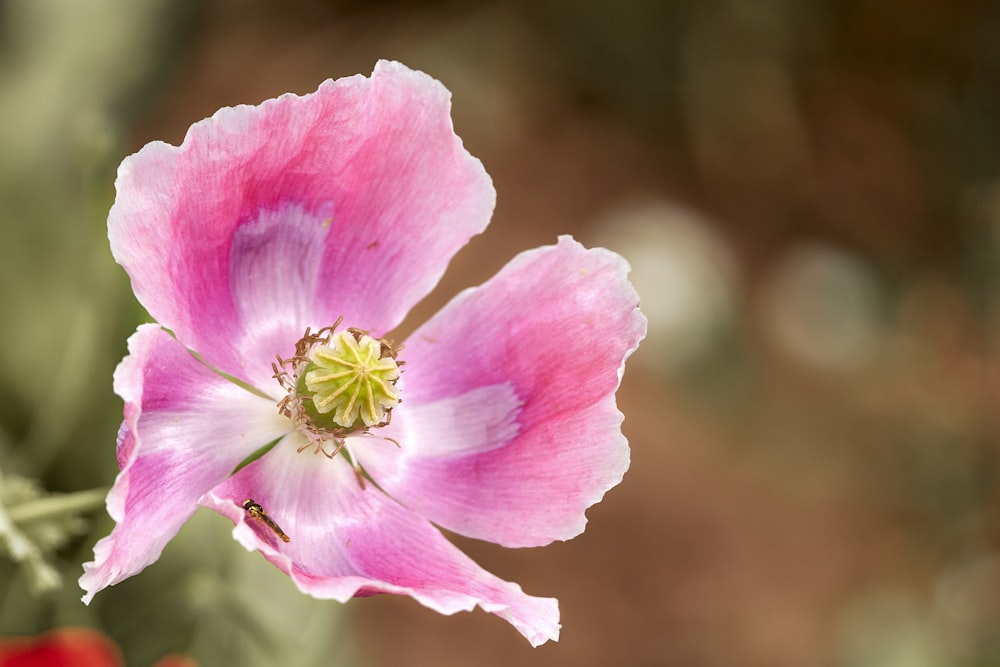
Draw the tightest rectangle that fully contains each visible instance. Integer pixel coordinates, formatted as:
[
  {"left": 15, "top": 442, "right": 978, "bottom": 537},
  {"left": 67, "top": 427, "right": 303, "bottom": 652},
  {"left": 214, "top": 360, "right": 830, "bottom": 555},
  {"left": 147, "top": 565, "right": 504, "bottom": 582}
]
[{"left": 758, "top": 243, "right": 881, "bottom": 372}]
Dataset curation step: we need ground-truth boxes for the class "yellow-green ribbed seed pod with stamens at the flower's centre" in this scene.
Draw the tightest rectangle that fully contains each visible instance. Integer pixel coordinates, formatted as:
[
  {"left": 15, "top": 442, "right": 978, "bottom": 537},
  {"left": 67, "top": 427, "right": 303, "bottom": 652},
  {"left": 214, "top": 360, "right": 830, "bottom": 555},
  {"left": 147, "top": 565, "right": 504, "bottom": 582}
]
[{"left": 273, "top": 320, "right": 403, "bottom": 457}]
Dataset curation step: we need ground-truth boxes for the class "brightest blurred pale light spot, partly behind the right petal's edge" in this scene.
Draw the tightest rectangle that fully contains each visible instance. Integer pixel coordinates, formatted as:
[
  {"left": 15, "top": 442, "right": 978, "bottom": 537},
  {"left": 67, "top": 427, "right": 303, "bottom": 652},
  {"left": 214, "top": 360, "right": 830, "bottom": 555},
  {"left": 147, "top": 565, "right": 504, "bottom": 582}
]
[{"left": 597, "top": 201, "right": 737, "bottom": 371}]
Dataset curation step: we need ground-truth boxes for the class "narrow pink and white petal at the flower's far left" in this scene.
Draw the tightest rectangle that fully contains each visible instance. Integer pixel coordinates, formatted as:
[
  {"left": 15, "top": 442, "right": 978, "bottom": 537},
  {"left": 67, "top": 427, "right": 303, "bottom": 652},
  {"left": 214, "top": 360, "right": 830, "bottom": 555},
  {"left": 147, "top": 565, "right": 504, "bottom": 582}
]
[{"left": 80, "top": 324, "right": 290, "bottom": 603}]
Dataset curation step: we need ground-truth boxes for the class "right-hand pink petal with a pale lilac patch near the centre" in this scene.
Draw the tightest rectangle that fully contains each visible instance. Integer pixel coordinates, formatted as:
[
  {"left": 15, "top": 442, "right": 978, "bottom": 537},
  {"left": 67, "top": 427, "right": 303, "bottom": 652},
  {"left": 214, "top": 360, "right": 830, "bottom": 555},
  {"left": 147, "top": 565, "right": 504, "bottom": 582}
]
[{"left": 354, "top": 237, "right": 646, "bottom": 546}]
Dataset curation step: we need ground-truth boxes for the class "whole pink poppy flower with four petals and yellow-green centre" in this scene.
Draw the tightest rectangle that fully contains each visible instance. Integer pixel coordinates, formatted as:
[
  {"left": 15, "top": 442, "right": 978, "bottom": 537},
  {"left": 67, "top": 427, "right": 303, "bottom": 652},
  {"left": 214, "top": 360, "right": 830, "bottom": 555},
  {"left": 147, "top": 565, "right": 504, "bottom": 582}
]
[{"left": 80, "top": 62, "right": 645, "bottom": 645}]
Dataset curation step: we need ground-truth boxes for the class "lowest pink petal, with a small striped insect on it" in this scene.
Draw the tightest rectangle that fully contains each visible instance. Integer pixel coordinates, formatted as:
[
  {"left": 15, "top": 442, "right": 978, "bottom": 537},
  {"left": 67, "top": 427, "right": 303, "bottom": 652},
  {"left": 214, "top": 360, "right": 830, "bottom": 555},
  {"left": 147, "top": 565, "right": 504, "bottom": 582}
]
[{"left": 202, "top": 444, "right": 559, "bottom": 646}]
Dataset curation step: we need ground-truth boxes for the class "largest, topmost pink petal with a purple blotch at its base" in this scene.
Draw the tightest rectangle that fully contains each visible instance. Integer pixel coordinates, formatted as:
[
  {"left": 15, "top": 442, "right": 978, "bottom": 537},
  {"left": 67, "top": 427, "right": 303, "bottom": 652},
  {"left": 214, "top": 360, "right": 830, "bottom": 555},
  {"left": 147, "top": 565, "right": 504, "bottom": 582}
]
[{"left": 108, "top": 61, "right": 495, "bottom": 389}]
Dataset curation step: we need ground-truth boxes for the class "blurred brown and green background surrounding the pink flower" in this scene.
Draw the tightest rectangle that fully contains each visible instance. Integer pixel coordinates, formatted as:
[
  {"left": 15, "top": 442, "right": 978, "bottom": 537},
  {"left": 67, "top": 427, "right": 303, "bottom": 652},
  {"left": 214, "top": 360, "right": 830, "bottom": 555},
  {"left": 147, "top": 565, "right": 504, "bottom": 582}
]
[{"left": 0, "top": 0, "right": 1000, "bottom": 667}]
